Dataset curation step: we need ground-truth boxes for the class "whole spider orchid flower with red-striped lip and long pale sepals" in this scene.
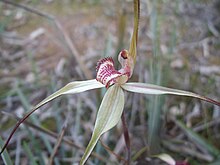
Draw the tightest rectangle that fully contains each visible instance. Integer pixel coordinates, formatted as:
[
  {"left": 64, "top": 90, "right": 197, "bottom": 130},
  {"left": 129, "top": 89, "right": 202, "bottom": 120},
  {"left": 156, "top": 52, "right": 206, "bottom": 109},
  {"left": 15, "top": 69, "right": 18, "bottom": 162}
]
[{"left": 1, "top": 0, "right": 220, "bottom": 164}]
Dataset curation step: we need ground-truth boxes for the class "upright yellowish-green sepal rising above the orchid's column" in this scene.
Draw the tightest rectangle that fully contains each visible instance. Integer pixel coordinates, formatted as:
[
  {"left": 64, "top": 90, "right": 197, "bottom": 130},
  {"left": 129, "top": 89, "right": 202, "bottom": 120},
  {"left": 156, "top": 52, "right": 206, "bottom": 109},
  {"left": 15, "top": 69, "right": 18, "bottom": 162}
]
[{"left": 129, "top": 0, "right": 140, "bottom": 63}]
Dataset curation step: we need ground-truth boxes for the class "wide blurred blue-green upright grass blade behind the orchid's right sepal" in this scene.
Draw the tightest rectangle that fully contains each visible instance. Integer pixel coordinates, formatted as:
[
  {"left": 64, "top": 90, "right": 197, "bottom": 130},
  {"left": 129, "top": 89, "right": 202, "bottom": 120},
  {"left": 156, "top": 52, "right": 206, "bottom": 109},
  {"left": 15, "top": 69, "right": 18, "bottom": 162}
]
[{"left": 147, "top": 0, "right": 163, "bottom": 154}]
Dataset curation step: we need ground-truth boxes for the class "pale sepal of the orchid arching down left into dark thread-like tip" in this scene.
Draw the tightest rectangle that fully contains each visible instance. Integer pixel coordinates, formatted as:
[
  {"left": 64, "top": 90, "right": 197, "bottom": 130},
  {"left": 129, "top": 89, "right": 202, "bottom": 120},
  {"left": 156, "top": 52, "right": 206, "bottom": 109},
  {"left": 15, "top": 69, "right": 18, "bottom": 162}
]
[{"left": 0, "top": 79, "right": 104, "bottom": 154}]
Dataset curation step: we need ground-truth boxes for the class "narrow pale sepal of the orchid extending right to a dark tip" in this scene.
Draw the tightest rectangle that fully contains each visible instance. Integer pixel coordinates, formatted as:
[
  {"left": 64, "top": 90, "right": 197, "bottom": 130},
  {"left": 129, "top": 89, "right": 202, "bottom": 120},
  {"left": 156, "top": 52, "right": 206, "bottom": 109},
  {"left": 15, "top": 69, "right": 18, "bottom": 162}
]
[{"left": 121, "top": 83, "right": 220, "bottom": 106}]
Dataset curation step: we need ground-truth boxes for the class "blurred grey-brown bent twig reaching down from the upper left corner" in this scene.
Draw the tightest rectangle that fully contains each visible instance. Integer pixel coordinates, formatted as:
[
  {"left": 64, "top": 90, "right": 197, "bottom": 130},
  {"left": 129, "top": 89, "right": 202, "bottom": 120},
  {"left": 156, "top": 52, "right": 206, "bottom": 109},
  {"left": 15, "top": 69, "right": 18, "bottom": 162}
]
[{"left": 0, "top": 0, "right": 92, "bottom": 79}]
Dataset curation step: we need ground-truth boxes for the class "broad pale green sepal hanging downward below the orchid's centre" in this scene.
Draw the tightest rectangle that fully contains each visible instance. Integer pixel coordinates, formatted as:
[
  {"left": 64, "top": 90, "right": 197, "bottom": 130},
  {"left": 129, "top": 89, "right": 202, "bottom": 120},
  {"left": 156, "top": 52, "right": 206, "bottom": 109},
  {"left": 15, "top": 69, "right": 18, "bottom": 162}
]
[{"left": 80, "top": 84, "right": 124, "bottom": 164}]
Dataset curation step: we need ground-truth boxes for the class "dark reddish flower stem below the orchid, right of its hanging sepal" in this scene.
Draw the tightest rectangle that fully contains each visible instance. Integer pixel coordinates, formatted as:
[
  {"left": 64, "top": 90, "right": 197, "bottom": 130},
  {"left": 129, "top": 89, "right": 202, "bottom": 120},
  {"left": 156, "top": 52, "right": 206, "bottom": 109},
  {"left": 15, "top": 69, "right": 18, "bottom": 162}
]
[{"left": 121, "top": 111, "right": 131, "bottom": 165}]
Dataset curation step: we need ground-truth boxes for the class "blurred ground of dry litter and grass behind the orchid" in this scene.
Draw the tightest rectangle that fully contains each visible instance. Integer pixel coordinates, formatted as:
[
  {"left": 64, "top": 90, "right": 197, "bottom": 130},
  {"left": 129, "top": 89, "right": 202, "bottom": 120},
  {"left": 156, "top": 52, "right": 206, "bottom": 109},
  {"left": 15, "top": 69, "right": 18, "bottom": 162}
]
[{"left": 0, "top": 0, "right": 220, "bottom": 165}]
